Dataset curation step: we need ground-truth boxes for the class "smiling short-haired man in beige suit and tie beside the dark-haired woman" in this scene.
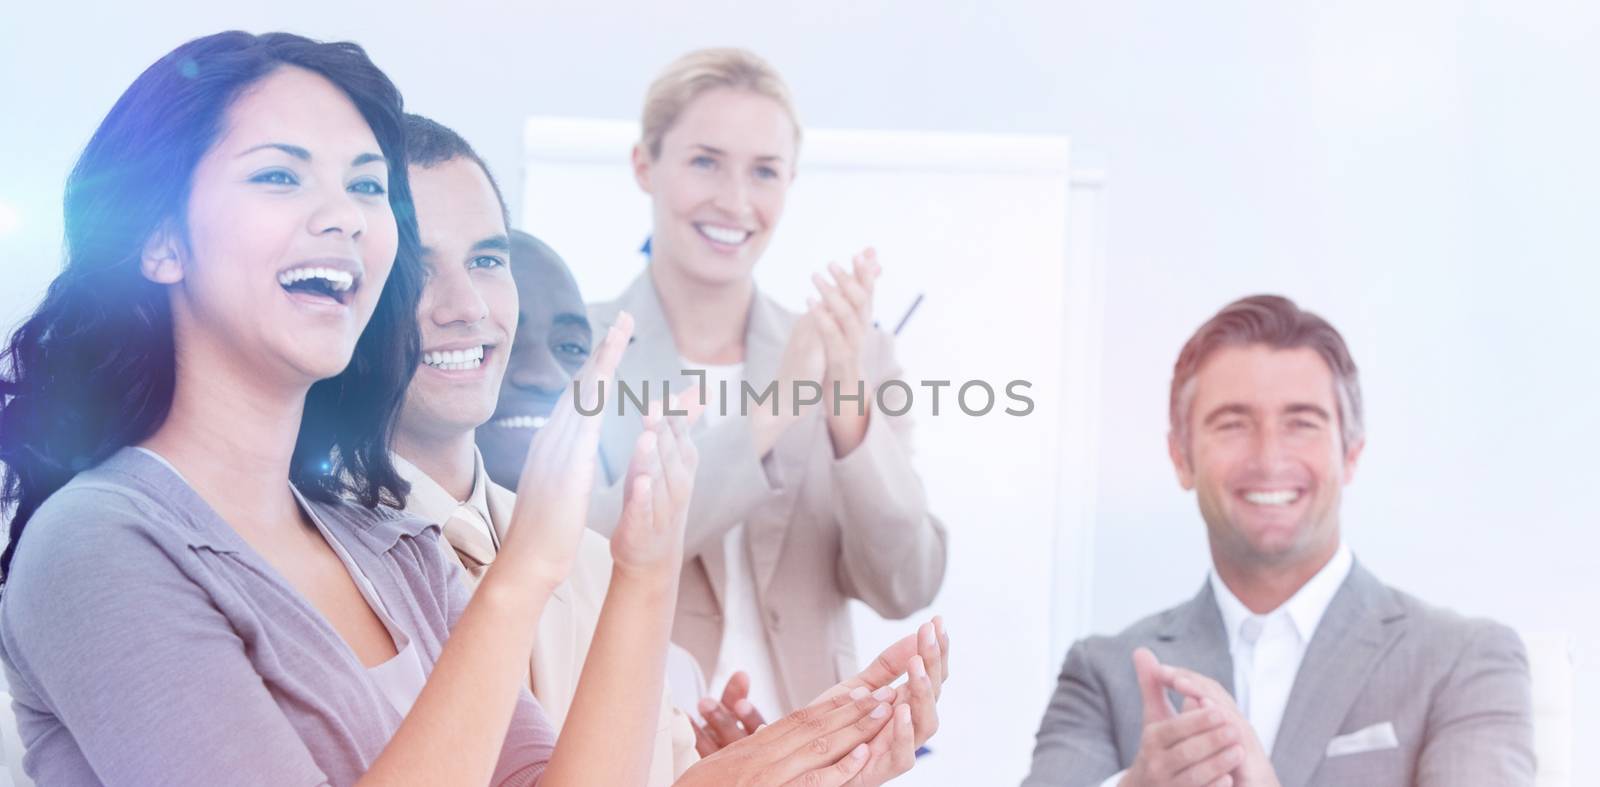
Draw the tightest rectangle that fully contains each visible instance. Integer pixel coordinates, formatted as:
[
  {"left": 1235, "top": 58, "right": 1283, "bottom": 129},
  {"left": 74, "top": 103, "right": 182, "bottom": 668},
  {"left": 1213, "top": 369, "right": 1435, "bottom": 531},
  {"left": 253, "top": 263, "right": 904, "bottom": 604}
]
[{"left": 394, "top": 115, "right": 698, "bottom": 787}]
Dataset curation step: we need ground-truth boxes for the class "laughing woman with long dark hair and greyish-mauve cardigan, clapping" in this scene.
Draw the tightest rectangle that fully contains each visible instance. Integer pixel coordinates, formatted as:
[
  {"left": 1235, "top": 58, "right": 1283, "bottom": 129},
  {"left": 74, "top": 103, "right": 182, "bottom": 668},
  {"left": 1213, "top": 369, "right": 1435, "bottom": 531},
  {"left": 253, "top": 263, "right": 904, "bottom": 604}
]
[{"left": 0, "top": 32, "right": 693, "bottom": 785}]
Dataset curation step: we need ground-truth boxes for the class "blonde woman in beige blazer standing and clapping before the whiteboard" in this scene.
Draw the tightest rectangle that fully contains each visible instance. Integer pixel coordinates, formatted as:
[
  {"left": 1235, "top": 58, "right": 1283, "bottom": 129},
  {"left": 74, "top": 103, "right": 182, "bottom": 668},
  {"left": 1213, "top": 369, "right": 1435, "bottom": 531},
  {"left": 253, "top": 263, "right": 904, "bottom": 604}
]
[{"left": 590, "top": 50, "right": 947, "bottom": 744}]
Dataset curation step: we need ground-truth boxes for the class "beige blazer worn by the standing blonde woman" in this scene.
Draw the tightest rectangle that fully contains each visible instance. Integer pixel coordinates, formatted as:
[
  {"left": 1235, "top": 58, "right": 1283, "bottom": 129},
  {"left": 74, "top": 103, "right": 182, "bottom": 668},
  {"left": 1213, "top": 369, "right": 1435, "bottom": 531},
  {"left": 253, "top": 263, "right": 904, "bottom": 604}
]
[{"left": 589, "top": 269, "right": 946, "bottom": 713}]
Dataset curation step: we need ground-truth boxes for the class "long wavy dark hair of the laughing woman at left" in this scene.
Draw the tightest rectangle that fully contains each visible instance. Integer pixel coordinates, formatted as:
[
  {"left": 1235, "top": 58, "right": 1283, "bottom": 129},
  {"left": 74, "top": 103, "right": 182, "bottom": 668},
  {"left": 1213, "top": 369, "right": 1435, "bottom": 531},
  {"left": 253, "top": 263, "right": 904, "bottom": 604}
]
[{"left": 0, "top": 32, "right": 422, "bottom": 584}]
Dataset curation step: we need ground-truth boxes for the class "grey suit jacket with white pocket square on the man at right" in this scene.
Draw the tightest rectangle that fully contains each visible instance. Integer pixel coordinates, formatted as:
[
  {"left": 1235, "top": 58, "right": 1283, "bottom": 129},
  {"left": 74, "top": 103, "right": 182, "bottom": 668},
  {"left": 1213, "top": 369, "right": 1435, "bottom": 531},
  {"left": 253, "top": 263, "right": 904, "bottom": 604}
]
[{"left": 1024, "top": 561, "right": 1534, "bottom": 787}]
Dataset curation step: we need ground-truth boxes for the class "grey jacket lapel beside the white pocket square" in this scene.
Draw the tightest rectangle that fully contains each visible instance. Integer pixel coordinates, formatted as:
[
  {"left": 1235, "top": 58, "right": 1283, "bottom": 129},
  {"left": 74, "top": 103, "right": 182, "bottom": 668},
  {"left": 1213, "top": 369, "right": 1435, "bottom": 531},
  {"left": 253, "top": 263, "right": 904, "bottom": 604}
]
[{"left": 1272, "top": 563, "right": 1405, "bottom": 787}]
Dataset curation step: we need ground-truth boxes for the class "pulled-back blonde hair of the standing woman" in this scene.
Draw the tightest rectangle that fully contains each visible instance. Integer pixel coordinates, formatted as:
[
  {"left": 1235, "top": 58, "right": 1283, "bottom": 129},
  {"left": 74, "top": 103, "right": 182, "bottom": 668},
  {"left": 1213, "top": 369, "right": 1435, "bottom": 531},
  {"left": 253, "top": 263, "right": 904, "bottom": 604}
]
[{"left": 638, "top": 48, "right": 800, "bottom": 158}]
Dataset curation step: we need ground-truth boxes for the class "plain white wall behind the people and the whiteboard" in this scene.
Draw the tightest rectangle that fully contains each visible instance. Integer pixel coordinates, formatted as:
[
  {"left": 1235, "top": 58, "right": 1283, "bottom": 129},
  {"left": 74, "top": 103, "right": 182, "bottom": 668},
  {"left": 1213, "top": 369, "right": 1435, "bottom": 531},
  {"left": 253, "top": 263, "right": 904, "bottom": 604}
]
[{"left": 0, "top": 0, "right": 1600, "bottom": 784}]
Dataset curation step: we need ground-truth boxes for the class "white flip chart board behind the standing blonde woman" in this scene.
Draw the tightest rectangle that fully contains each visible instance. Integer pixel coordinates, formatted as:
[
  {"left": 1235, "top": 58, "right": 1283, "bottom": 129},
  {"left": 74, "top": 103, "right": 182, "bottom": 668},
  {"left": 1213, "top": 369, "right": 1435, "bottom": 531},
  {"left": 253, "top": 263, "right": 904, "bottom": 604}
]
[{"left": 522, "top": 117, "right": 1104, "bottom": 785}]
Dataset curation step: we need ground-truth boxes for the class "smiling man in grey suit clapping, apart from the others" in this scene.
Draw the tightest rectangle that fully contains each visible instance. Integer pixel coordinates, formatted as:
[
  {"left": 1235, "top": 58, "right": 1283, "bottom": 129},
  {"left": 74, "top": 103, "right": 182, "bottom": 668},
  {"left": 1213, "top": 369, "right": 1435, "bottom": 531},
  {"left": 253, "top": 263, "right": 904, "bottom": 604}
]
[{"left": 1024, "top": 296, "right": 1534, "bottom": 787}]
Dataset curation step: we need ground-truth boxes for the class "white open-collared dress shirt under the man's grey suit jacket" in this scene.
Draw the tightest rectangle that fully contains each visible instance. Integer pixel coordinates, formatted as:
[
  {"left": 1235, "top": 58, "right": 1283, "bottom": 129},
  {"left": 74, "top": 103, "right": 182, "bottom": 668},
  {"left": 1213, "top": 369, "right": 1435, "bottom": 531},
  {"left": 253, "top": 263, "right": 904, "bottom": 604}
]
[{"left": 1101, "top": 542, "right": 1355, "bottom": 787}]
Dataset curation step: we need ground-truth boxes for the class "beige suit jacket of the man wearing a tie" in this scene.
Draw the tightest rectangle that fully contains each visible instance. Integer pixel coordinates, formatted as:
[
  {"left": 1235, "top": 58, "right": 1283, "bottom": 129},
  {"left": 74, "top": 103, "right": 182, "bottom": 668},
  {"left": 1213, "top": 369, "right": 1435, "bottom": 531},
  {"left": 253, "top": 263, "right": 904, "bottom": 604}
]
[{"left": 395, "top": 456, "right": 699, "bottom": 787}]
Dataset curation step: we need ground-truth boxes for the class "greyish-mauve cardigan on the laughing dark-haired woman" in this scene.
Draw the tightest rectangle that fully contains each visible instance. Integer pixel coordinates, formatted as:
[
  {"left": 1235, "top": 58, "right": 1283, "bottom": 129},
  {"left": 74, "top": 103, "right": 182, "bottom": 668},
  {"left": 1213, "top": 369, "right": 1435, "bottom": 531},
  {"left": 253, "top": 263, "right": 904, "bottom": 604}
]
[{"left": 0, "top": 448, "right": 555, "bottom": 787}]
